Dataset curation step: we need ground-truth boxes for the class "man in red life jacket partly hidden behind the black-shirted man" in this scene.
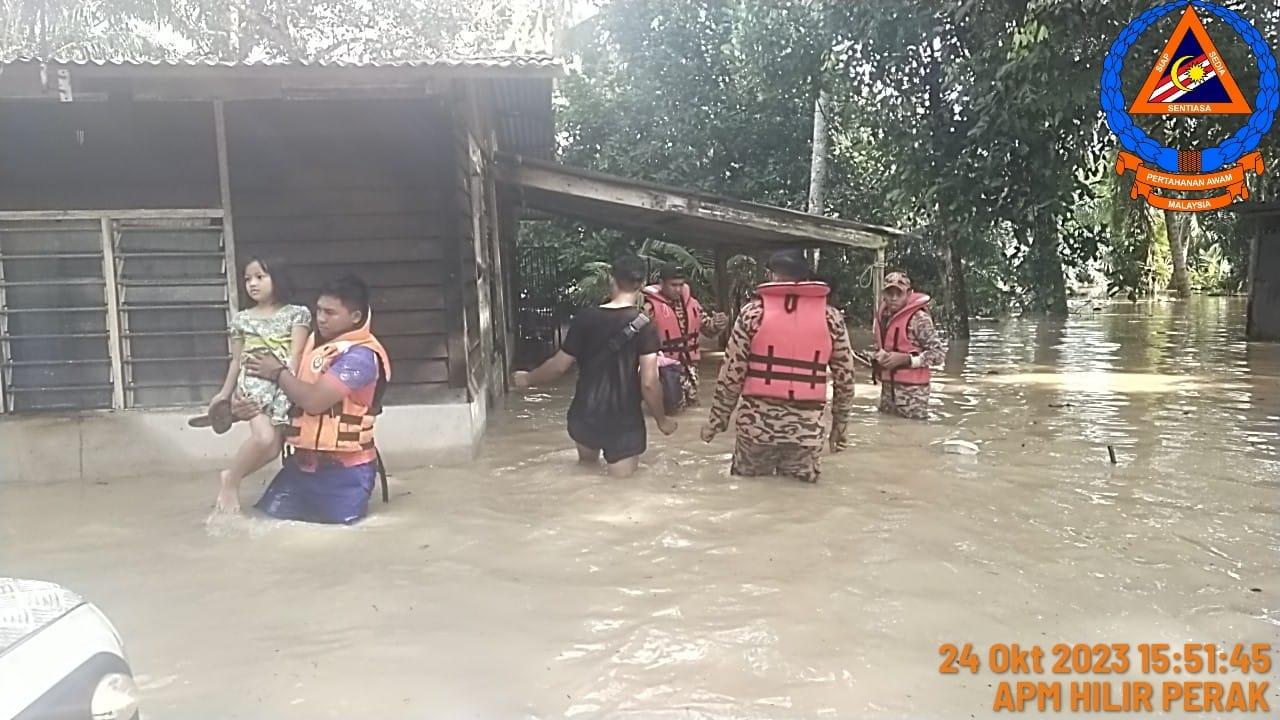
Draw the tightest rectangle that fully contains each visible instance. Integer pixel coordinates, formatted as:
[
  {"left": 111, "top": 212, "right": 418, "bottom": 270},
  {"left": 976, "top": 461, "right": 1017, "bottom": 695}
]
[{"left": 640, "top": 263, "right": 728, "bottom": 407}]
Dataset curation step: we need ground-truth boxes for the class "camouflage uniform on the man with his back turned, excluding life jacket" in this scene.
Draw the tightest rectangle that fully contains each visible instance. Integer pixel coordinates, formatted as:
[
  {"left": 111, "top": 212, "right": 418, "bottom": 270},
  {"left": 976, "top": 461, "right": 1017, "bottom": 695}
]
[{"left": 708, "top": 300, "right": 854, "bottom": 483}]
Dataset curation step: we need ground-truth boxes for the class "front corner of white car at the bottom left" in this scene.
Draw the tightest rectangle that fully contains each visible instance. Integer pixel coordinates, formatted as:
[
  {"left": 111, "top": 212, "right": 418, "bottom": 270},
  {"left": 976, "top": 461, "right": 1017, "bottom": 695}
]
[{"left": 0, "top": 578, "right": 138, "bottom": 720}]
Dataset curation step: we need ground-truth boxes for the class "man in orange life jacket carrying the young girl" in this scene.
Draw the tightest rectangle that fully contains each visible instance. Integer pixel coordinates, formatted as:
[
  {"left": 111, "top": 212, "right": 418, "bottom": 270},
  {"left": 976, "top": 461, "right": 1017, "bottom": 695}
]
[{"left": 232, "top": 275, "right": 390, "bottom": 524}]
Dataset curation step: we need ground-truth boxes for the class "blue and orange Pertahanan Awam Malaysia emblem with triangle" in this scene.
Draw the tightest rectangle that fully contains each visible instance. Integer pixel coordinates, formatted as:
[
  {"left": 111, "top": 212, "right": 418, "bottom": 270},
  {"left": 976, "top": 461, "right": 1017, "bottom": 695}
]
[{"left": 1102, "top": 0, "right": 1280, "bottom": 213}]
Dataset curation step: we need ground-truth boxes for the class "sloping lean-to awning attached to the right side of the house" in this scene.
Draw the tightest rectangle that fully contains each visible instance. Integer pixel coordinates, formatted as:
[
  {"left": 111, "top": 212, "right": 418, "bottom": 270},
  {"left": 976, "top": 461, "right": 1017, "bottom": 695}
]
[{"left": 497, "top": 155, "right": 915, "bottom": 250}]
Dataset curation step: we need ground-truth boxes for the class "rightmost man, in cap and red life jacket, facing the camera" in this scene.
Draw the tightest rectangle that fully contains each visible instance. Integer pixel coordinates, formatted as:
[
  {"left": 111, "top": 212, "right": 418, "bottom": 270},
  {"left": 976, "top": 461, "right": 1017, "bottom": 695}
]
[{"left": 872, "top": 272, "right": 946, "bottom": 420}]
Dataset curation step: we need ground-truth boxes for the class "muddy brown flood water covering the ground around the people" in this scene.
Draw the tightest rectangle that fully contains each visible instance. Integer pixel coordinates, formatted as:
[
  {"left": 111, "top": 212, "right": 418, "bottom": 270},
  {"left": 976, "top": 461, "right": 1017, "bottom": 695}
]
[{"left": 0, "top": 299, "right": 1280, "bottom": 719}]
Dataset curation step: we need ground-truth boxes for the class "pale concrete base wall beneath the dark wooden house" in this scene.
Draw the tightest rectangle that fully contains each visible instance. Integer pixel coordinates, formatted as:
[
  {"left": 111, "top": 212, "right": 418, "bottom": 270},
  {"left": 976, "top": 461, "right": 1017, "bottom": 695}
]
[{"left": 0, "top": 397, "right": 486, "bottom": 483}]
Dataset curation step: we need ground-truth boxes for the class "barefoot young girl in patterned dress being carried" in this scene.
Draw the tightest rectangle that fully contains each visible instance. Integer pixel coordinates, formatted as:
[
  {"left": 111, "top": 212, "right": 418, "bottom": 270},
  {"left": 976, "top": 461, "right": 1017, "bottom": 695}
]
[{"left": 209, "top": 258, "right": 311, "bottom": 512}]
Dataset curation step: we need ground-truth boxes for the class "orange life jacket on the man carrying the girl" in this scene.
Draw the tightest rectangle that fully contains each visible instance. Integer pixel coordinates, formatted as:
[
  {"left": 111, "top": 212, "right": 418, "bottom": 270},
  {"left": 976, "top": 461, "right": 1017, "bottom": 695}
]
[{"left": 284, "top": 320, "right": 392, "bottom": 452}]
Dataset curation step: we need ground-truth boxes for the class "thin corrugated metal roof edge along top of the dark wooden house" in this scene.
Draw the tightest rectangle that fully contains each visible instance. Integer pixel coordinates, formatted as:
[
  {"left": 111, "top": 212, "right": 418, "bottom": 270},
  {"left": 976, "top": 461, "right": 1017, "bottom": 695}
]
[{"left": 3, "top": 55, "right": 564, "bottom": 74}]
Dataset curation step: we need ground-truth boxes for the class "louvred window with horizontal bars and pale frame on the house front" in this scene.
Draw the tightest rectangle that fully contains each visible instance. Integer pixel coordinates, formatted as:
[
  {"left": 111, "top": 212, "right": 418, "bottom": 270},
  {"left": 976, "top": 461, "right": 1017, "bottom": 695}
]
[{"left": 0, "top": 210, "right": 227, "bottom": 413}]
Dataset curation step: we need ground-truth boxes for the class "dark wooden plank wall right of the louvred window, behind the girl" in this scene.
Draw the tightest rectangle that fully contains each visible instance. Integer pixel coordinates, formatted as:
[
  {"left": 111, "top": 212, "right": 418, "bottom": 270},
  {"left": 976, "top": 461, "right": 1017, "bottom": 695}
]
[{"left": 227, "top": 100, "right": 460, "bottom": 404}]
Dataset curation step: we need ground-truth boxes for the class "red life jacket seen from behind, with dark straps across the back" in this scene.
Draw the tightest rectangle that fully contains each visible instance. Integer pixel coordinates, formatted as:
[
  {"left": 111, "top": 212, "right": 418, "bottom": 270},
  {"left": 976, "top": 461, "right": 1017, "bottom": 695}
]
[{"left": 742, "top": 282, "right": 831, "bottom": 402}]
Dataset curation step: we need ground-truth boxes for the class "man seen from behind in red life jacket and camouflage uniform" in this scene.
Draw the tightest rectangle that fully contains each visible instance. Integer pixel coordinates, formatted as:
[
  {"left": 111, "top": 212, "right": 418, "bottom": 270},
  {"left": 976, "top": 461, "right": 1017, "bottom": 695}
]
[{"left": 701, "top": 252, "right": 854, "bottom": 483}]
